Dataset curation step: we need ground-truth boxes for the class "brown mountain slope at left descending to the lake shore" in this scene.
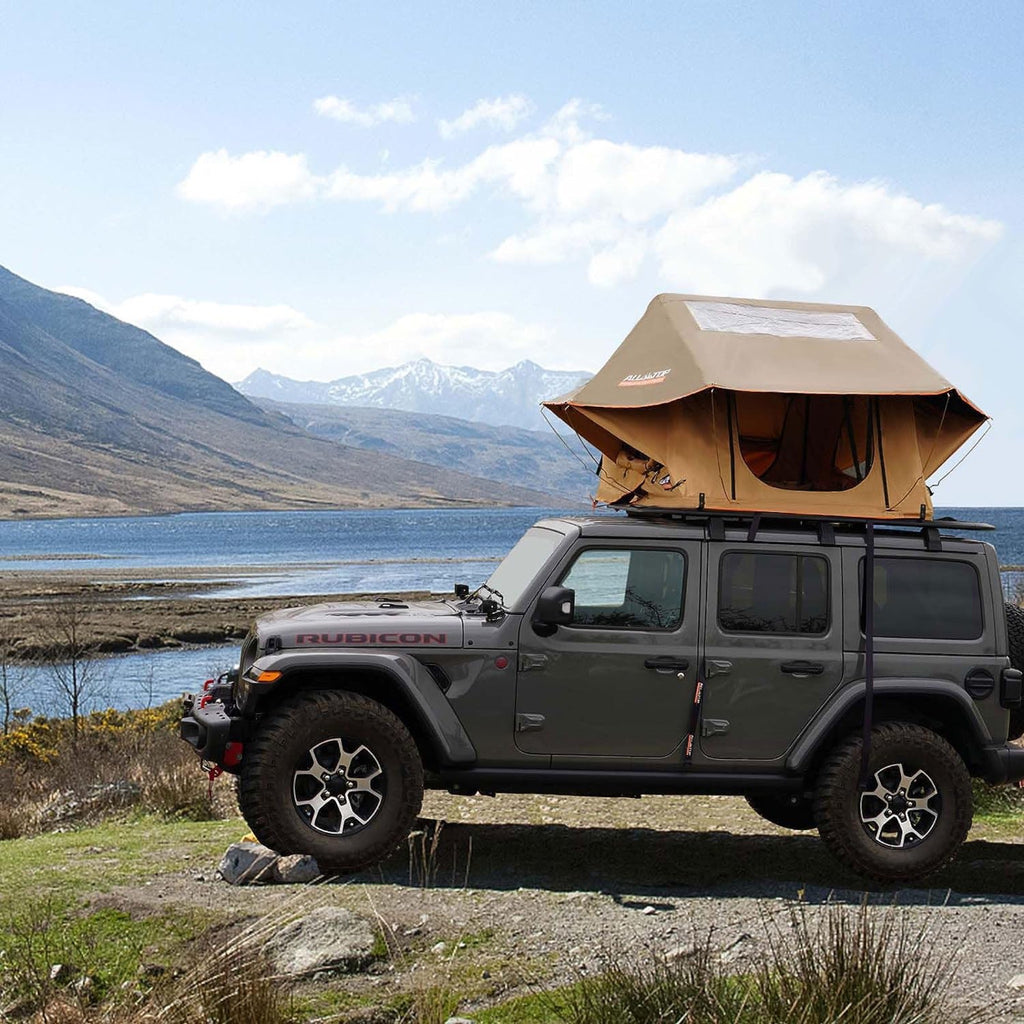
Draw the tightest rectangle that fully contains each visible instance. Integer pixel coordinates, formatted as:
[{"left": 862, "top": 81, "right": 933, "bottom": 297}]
[{"left": 0, "top": 267, "right": 551, "bottom": 517}]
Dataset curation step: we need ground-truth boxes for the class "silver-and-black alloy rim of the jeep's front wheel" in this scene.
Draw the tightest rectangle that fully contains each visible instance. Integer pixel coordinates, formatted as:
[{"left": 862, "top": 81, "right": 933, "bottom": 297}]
[{"left": 292, "top": 736, "right": 386, "bottom": 836}]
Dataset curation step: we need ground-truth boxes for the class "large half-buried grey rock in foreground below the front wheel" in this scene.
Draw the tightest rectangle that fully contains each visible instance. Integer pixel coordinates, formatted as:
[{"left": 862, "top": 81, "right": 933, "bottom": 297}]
[{"left": 266, "top": 906, "right": 376, "bottom": 977}]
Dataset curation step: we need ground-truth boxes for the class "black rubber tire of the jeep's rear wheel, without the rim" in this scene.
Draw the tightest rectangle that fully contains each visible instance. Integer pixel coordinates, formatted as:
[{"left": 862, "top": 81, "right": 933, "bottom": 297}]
[{"left": 814, "top": 722, "right": 974, "bottom": 882}]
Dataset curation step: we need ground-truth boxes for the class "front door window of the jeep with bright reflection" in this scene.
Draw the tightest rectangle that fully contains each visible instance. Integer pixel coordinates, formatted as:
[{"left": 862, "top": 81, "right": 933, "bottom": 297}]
[{"left": 561, "top": 548, "right": 686, "bottom": 630}]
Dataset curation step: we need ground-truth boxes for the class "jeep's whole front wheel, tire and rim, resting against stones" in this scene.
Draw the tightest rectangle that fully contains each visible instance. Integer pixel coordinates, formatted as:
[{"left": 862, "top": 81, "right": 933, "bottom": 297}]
[{"left": 239, "top": 690, "right": 423, "bottom": 871}]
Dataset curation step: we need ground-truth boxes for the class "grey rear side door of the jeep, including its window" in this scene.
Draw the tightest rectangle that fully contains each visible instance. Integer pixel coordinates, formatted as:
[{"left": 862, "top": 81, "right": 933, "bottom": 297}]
[{"left": 700, "top": 543, "right": 843, "bottom": 761}]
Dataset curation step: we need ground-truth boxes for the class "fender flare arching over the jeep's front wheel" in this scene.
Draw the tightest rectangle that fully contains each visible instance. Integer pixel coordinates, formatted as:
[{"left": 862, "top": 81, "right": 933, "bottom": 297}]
[{"left": 246, "top": 650, "right": 476, "bottom": 765}]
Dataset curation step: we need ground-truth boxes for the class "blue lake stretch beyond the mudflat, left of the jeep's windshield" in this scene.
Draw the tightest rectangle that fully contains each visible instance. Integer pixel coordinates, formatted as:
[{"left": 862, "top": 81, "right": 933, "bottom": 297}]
[{"left": 0, "top": 508, "right": 565, "bottom": 597}]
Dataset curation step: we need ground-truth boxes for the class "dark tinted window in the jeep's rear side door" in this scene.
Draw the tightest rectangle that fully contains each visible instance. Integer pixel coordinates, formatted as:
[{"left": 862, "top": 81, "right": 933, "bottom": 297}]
[{"left": 718, "top": 551, "right": 828, "bottom": 635}]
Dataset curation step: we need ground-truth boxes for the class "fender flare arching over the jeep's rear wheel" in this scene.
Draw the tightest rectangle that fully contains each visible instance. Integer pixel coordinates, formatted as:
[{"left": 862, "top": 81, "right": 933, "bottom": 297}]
[{"left": 785, "top": 679, "right": 992, "bottom": 773}]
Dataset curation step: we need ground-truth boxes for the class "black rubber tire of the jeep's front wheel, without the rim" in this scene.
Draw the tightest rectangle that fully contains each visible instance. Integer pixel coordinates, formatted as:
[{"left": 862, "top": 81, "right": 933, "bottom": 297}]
[{"left": 238, "top": 690, "right": 423, "bottom": 871}]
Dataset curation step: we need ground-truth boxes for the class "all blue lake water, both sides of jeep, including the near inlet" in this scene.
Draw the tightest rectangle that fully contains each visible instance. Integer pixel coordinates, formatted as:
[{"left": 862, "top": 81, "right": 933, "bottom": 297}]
[{"left": 0, "top": 508, "right": 1024, "bottom": 713}]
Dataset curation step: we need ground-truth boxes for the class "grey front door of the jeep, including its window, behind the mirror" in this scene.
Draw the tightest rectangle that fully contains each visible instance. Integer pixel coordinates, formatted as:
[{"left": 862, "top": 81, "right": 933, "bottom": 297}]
[{"left": 515, "top": 541, "right": 700, "bottom": 758}]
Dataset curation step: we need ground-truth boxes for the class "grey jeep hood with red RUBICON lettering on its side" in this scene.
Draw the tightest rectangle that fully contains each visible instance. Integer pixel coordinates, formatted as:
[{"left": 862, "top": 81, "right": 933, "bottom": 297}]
[{"left": 256, "top": 601, "right": 463, "bottom": 650}]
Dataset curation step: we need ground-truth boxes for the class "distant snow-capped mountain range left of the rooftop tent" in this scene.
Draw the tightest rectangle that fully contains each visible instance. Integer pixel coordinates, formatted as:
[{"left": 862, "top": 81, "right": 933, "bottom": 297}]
[{"left": 234, "top": 359, "right": 591, "bottom": 430}]
